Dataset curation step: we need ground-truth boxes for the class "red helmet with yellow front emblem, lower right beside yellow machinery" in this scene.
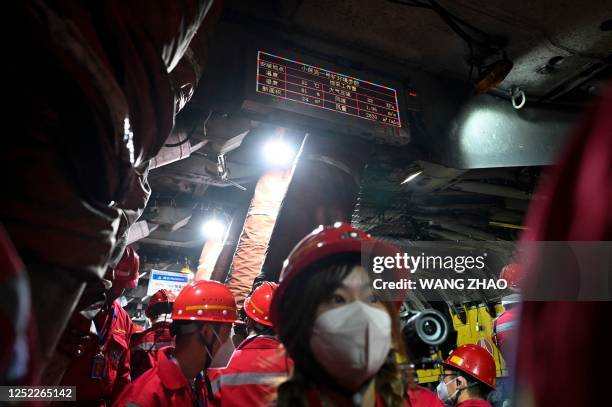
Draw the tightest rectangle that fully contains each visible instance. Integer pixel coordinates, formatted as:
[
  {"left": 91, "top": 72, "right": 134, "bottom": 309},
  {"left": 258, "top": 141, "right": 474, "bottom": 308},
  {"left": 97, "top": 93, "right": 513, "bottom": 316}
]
[{"left": 442, "top": 344, "right": 496, "bottom": 389}]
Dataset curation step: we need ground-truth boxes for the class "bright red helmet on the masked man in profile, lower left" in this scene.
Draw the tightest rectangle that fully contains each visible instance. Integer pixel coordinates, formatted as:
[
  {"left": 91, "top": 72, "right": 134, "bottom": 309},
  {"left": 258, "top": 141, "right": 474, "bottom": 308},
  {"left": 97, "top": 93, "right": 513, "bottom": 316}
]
[{"left": 172, "top": 280, "right": 240, "bottom": 323}]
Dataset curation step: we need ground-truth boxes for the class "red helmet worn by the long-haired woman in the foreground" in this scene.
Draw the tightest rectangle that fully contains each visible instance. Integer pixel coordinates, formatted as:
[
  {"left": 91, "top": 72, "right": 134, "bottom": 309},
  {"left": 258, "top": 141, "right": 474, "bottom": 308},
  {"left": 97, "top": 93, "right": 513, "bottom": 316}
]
[{"left": 270, "top": 222, "right": 401, "bottom": 332}]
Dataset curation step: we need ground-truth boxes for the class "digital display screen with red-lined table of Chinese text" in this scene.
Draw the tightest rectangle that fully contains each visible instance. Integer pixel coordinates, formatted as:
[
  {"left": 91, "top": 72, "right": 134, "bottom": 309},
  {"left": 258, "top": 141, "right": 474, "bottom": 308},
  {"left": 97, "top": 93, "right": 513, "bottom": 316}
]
[{"left": 257, "top": 51, "right": 401, "bottom": 127}]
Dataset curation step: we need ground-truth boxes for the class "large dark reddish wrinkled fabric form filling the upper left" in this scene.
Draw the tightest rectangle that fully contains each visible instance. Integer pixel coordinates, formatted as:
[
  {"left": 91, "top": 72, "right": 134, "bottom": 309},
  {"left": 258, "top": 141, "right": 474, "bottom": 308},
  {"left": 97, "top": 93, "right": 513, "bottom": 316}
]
[{"left": 0, "top": 0, "right": 223, "bottom": 382}]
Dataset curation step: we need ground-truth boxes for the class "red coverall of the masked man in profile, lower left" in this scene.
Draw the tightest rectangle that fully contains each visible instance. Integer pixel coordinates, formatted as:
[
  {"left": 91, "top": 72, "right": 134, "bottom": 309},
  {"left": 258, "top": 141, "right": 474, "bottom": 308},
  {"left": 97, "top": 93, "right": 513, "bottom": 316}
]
[{"left": 113, "top": 346, "right": 206, "bottom": 407}]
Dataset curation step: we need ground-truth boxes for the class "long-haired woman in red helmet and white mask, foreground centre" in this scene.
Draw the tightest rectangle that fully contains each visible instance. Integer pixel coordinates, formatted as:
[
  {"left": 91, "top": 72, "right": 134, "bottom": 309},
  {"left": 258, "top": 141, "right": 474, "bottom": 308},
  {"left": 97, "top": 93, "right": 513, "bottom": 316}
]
[{"left": 271, "top": 223, "right": 439, "bottom": 407}]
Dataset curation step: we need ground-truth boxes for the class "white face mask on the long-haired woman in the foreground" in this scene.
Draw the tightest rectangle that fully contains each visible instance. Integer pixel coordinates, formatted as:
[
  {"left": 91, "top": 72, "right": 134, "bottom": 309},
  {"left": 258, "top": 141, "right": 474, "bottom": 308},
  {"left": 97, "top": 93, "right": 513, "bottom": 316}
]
[{"left": 310, "top": 301, "right": 391, "bottom": 391}]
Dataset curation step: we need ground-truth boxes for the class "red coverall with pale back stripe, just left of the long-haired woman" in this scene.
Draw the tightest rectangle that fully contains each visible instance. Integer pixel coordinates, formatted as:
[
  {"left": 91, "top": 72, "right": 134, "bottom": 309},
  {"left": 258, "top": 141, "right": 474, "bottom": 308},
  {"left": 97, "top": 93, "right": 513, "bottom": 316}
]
[{"left": 207, "top": 335, "right": 293, "bottom": 407}]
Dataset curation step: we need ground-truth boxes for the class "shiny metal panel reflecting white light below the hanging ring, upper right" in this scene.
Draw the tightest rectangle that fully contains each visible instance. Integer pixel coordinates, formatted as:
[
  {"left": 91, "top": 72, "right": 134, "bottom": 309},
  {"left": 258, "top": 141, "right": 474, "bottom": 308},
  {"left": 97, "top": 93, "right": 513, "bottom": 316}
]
[{"left": 437, "top": 95, "right": 577, "bottom": 168}]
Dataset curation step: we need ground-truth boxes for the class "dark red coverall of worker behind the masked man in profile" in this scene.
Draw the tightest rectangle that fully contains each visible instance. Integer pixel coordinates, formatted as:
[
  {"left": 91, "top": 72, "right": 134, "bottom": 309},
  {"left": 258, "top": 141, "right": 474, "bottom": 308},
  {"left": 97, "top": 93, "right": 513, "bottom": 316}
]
[{"left": 130, "top": 321, "right": 174, "bottom": 380}]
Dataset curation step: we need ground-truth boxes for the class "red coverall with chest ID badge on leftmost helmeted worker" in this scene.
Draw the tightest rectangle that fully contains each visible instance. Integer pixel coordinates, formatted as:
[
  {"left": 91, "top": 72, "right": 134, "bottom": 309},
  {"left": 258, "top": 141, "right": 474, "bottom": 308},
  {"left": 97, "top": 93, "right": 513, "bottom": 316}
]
[{"left": 59, "top": 301, "right": 132, "bottom": 406}]
